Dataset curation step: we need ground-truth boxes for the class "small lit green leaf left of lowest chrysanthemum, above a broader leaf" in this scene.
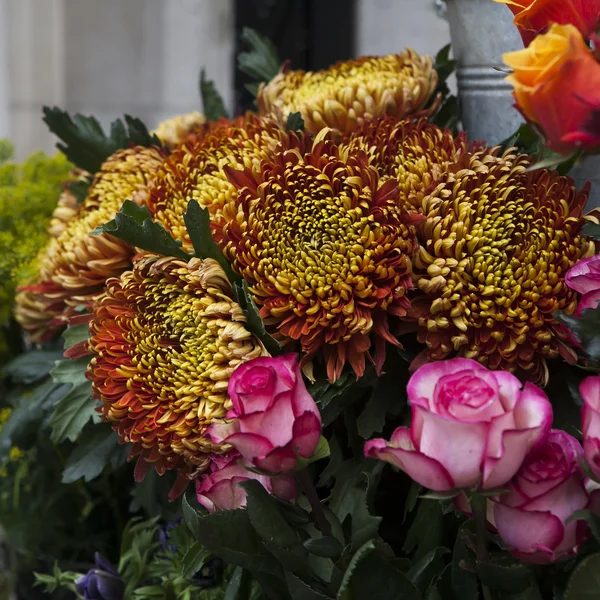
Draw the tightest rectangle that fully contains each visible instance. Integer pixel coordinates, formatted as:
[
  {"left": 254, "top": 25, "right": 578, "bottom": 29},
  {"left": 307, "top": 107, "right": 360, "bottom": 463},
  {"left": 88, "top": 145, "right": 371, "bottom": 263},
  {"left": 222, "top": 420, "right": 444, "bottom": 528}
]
[{"left": 49, "top": 381, "right": 97, "bottom": 444}]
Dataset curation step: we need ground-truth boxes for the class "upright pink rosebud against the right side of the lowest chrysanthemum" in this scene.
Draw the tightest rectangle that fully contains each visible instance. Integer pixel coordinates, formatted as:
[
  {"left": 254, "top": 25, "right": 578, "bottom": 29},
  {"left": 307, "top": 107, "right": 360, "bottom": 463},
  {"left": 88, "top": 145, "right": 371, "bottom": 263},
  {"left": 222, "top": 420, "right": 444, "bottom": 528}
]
[{"left": 207, "top": 354, "right": 321, "bottom": 473}]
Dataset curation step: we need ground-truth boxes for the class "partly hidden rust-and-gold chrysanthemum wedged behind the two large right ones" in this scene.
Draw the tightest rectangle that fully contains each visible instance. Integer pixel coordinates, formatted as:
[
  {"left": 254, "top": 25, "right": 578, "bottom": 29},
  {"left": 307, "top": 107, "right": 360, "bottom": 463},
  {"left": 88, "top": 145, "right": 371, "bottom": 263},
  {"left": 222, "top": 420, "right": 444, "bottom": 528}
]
[{"left": 341, "top": 117, "right": 468, "bottom": 210}]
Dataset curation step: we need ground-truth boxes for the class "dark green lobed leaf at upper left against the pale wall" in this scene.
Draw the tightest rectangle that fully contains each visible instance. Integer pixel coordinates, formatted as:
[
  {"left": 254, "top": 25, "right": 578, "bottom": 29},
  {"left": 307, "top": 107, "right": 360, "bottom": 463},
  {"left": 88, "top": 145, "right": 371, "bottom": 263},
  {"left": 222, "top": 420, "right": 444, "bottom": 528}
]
[{"left": 44, "top": 106, "right": 161, "bottom": 173}]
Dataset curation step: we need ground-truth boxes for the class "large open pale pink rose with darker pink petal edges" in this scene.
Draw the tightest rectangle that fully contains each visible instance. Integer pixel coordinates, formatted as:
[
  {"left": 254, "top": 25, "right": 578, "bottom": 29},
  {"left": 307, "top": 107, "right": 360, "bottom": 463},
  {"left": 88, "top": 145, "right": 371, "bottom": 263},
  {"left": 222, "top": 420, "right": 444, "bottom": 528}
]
[{"left": 365, "top": 358, "right": 552, "bottom": 491}]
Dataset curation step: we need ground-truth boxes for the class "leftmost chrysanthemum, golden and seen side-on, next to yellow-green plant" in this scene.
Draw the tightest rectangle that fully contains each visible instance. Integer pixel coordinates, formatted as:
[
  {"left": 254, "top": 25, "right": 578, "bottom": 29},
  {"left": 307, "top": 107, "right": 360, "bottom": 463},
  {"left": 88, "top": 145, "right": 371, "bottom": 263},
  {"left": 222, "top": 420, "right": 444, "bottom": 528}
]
[{"left": 15, "top": 146, "right": 165, "bottom": 341}]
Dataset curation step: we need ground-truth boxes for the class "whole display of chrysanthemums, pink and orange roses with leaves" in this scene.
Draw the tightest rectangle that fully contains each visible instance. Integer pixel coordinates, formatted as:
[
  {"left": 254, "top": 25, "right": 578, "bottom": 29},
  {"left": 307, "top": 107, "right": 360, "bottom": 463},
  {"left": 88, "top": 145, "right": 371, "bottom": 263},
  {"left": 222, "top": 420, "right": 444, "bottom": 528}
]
[{"left": 0, "top": 0, "right": 600, "bottom": 600}]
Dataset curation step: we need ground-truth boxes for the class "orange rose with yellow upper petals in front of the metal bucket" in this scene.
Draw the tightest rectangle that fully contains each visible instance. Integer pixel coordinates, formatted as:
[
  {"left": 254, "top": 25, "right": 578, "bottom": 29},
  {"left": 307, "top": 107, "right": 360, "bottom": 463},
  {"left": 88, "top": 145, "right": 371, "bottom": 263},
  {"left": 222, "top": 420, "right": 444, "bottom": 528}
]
[{"left": 504, "top": 25, "right": 600, "bottom": 154}]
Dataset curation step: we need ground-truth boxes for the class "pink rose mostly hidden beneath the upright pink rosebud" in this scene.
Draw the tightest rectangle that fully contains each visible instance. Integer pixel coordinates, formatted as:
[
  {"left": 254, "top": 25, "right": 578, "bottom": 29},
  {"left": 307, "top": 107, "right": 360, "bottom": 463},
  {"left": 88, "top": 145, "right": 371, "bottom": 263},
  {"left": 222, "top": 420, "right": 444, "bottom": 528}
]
[{"left": 196, "top": 451, "right": 297, "bottom": 512}]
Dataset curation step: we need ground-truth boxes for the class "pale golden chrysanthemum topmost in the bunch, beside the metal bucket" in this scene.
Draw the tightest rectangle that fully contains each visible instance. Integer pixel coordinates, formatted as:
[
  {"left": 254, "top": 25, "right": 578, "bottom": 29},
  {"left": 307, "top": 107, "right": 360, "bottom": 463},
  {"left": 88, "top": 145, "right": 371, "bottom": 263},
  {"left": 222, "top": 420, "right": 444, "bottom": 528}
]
[{"left": 257, "top": 49, "right": 438, "bottom": 135}]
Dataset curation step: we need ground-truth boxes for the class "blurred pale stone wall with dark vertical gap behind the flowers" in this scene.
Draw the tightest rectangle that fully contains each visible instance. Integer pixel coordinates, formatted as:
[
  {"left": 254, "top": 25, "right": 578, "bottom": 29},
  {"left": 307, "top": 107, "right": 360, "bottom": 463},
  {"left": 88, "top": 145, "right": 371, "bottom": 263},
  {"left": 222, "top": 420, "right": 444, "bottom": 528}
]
[{"left": 0, "top": 0, "right": 449, "bottom": 158}]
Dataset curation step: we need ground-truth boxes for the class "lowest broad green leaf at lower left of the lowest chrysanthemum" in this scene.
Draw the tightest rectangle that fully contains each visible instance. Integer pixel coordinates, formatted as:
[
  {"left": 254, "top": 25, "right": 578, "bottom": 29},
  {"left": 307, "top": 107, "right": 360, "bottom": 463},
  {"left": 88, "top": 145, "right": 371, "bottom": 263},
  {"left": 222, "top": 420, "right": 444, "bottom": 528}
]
[{"left": 62, "top": 423, "right": 128, "bottom": 483}]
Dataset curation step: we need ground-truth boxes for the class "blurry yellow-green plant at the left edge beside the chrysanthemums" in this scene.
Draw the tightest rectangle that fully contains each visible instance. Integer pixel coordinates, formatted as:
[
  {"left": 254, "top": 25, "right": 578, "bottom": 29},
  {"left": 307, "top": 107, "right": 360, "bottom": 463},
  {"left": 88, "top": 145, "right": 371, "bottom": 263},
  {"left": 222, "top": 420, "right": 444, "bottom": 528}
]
[{"left": 0, "top": 140, "right": 72, "bottom": 359}]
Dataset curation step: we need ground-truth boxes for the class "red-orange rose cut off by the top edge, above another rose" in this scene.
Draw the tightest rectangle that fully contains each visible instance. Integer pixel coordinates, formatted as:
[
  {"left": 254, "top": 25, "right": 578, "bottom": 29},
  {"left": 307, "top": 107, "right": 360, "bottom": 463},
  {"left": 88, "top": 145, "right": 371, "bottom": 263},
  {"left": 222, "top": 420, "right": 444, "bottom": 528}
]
[{"left": 494, "top": 0, "right": 600, "bottom": 46}]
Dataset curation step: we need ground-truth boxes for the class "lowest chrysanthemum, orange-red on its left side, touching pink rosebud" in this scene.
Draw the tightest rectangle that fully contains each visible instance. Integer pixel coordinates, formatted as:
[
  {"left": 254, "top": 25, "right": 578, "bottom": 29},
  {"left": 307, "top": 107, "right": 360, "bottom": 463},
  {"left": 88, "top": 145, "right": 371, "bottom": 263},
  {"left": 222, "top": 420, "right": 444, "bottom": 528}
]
[{"left": 88, "top": 255, "right": 266, "bottom": 475}]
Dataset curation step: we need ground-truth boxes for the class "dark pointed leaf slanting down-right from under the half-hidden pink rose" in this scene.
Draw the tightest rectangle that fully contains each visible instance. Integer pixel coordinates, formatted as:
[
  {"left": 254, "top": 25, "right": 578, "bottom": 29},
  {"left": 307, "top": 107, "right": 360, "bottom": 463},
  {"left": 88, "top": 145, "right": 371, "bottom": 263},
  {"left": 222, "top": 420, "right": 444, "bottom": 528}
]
[{"left": 239, "top": 479, "right": 302, "bottom": 549}]
